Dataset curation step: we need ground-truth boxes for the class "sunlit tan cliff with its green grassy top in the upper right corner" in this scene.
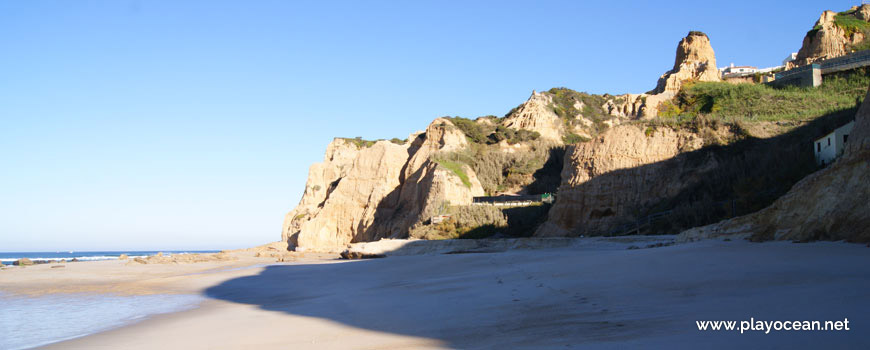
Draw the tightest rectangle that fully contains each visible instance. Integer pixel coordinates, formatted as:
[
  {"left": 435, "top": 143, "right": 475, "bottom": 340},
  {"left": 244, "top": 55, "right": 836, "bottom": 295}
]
[{"left": 786, "top": 4, "right": 870, "bottom": 69}]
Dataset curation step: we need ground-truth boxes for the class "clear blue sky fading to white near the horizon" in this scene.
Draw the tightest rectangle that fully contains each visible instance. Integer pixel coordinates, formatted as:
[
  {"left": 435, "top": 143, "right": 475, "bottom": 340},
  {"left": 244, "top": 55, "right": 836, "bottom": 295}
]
[{"left": 0, "top": 0, "right": 860, "bottom": 251}]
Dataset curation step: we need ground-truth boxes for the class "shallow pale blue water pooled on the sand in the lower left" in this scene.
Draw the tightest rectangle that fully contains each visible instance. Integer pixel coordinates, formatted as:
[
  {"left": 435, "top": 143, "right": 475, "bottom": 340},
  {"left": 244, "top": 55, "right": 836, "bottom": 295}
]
[{"left": 0, "top": 293, "right": 204, "bottom": 349}]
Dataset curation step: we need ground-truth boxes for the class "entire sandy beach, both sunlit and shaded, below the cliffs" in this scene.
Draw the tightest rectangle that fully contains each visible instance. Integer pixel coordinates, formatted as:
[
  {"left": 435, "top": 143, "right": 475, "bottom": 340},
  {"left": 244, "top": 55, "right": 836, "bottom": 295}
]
[{"left": 0, "top": 240, "right": 870, "bottom": 349}]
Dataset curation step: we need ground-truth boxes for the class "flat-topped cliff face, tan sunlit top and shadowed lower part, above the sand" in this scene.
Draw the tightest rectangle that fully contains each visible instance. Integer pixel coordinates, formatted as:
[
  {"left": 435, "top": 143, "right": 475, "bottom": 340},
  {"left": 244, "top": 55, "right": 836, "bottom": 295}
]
[{"left": 535, "top": 125, "right": 715, "bottom": 236}]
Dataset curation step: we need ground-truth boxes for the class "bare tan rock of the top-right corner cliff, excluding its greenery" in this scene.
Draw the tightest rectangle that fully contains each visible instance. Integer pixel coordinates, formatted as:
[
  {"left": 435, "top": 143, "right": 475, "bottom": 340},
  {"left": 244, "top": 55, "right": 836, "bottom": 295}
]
[{"left": 786, "top": 4, "right": 870, "bottom": 69}]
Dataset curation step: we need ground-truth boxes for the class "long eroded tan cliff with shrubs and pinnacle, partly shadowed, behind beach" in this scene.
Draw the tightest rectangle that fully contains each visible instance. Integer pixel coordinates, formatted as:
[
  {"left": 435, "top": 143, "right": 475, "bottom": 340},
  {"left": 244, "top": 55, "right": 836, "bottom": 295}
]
[{"left": 282, "top": 19, "right": 870, "bottom": 251}]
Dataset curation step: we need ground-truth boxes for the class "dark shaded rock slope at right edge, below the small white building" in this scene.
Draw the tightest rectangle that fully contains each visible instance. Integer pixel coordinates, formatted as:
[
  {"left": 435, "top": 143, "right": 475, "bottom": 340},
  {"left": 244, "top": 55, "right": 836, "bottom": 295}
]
[{"left": 680, "top": 87, "right": 870, "bottom": 242}]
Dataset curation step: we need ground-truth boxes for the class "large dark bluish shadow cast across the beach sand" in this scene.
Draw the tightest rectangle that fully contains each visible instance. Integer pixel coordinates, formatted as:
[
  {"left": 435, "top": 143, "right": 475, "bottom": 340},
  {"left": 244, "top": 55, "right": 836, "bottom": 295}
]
[{"left": 205, "top": 242, "right": 870, "bottom": 349}]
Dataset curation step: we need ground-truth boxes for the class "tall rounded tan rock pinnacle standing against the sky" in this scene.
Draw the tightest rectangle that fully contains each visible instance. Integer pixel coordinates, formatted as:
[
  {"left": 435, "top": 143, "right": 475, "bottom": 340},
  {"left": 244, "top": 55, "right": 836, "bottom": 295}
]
[{"left": 652, "top": 31, "right": 721, "bottom": 94}]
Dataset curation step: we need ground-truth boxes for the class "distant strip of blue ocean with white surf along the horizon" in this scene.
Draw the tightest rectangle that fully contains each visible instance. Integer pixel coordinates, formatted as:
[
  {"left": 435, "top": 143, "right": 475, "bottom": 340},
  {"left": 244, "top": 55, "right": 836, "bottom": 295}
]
[{"left": 0, "top": 250, "right": 219, "bottom": 265}]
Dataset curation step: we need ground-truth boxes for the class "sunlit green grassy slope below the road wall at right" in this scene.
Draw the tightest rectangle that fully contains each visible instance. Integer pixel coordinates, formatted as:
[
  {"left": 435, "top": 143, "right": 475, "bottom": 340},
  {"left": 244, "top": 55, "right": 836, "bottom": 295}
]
[{"left": 659, "top": 68, "right": 870, "bottom": 122}]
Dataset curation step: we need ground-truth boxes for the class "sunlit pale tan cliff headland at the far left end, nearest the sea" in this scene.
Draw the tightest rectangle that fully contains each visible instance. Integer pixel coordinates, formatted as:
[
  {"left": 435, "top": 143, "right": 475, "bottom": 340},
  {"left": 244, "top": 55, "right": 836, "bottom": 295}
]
[{"left": 282, "top": 118, "right": 483, "bottom": 251}]
